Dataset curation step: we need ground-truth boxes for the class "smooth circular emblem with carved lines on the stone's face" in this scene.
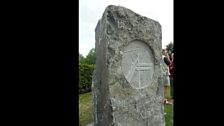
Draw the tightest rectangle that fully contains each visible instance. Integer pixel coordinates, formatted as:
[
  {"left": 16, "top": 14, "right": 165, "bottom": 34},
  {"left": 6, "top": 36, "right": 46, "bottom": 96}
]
[{"left": 121, "top": 40, "right": 154, "bottom": 89}]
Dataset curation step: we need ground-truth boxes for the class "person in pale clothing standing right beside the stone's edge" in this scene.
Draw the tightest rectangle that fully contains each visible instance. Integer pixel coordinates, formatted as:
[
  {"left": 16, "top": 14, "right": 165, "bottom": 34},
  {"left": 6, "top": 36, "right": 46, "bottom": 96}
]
[{"left": 161, "top": 49, "right": 170, "bottom": 103}]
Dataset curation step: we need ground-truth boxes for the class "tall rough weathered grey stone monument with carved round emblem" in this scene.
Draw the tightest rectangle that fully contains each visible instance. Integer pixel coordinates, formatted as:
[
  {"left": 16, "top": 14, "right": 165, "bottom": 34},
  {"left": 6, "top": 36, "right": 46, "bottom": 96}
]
[{"left": 92, "top": 5, "right": 165, "bottom": 126}]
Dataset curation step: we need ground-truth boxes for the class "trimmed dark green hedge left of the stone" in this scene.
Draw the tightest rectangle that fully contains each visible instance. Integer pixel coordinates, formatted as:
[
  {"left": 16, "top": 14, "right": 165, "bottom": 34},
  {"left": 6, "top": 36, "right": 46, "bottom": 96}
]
[{"left": 79, "top": 64, "right": 94, "bottom": 93}]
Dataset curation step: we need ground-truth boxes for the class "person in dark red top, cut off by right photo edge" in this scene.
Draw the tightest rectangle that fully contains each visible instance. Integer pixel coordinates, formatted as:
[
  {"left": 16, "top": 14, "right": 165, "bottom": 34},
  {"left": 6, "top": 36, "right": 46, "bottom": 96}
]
[{"left": 169, "top": 52, "right": 174, "bottom": 102}]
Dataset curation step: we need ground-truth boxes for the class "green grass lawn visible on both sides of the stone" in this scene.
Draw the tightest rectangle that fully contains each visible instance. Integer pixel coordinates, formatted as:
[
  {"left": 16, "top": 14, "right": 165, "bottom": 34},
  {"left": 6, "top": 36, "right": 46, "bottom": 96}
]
[{"left": 79, "top": 92, "right": 173, "bottom": 126}]
